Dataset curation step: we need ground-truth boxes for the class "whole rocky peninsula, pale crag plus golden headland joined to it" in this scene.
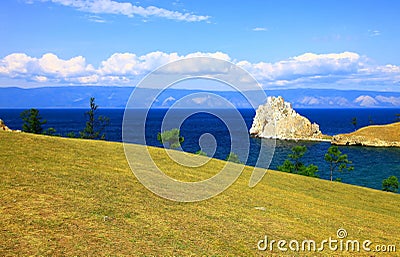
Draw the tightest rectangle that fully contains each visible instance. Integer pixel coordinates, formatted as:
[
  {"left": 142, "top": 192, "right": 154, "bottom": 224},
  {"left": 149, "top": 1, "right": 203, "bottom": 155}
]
[{"left": 249, "top": 96, "right": 400, "bottom": 147}]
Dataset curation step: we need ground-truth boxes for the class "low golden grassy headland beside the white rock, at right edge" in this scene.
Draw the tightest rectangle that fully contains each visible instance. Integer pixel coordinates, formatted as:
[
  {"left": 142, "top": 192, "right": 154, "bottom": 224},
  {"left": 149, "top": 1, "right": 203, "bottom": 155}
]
[{"left": 331, "top": 122, "right": 400, "bottom": 147}]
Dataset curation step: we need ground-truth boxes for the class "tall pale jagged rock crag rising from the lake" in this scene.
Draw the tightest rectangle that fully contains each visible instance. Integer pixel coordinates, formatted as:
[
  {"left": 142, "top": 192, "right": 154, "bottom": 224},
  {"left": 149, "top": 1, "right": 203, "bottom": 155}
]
[{"left": 250, "top": 96, "right": 324, "bottom": 140}]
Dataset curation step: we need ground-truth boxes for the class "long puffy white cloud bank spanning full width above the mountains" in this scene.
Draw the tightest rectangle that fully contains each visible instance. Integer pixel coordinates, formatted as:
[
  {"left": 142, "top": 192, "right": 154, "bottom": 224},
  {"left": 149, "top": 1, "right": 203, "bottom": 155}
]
[{"left": 0, "top": 51, "right": 400, "bottom": 90}]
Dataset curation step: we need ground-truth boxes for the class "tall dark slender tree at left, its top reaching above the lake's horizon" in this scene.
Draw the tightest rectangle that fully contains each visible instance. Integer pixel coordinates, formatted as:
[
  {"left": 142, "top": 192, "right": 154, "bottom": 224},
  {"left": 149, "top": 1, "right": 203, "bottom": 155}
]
[{"left": 79, "top": 97, "right": 110, "bottom": 140}]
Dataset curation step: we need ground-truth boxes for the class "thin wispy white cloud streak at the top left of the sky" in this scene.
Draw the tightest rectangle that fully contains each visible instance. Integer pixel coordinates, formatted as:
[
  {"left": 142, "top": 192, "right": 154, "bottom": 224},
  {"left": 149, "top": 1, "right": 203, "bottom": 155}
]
[{"left": 50, "top": 0, "right": 210, "bottom": 22}]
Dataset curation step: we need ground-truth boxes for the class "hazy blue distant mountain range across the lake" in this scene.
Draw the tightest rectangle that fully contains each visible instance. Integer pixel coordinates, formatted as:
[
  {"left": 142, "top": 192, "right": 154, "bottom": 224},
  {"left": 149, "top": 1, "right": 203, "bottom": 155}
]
[{"left": 0, "top": 86, "right": 400, "bottom": 108}]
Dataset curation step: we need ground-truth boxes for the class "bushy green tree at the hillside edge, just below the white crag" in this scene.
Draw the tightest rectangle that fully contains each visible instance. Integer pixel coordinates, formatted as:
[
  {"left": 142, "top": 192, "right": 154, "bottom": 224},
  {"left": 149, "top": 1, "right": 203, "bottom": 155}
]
[{"left": 278, "top": 145, "right": 318, "bottom": 177}]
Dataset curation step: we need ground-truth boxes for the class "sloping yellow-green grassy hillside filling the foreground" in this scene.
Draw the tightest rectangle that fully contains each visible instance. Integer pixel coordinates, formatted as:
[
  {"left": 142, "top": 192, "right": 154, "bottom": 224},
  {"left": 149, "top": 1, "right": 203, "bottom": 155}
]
[{"left": 0, "top": 132, "right": 400, "bottom": 256}]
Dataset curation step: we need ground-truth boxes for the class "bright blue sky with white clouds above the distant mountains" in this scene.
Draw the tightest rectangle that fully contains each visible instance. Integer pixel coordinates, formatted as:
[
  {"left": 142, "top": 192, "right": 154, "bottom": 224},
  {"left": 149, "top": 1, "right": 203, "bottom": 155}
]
[{"left": 0, "top": 0, "right": 400, "bottom": 92}]
